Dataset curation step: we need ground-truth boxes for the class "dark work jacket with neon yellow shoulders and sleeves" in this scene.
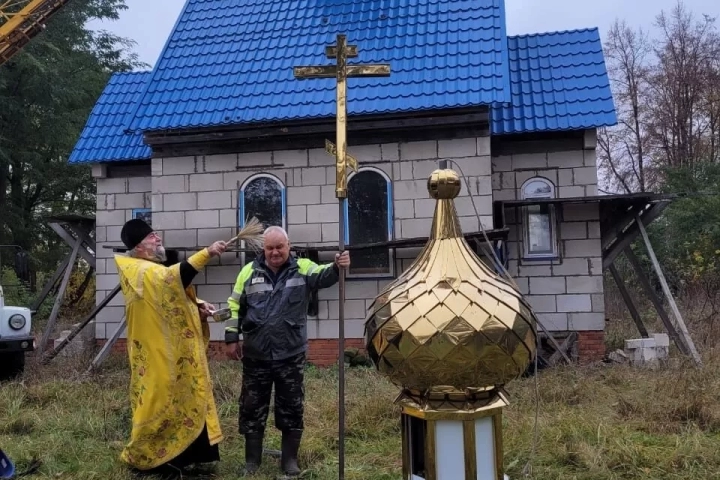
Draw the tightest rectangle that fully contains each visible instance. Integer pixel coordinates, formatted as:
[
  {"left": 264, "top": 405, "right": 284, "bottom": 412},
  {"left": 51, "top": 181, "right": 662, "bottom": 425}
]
[{"left": 225, "top": 254, "right": 339, "bottom": 360}]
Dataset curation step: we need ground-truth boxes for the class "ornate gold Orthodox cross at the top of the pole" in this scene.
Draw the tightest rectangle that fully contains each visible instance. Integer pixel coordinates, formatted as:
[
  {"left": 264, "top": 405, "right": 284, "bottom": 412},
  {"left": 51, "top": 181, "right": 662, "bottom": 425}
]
[{"left": 293, "top": 35, "right": 390, "bottom": 199}]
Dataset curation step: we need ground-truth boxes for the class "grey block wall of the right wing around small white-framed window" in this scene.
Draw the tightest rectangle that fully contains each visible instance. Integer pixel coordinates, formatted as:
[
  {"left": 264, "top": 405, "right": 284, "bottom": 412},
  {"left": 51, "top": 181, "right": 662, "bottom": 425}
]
[{"left": 492, "top": 129, "right": 605, "bottom": 338}]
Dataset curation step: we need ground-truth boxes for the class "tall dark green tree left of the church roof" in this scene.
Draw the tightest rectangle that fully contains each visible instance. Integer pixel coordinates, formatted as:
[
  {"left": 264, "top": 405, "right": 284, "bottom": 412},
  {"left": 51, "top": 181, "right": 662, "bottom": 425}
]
[{"left": 0, "top": 0, "right": 144, "bottom": 284}]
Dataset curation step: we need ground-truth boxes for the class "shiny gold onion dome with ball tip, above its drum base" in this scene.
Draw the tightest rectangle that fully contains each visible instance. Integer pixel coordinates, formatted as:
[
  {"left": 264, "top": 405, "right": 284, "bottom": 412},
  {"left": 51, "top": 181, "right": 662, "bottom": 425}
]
[{"left": 365, "top": 169, "right": 537, "bottom": 408}]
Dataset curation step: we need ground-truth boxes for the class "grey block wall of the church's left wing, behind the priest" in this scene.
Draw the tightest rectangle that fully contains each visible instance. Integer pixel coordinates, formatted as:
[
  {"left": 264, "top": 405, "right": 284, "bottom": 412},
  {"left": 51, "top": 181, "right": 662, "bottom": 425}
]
[{"left": 93, "top": 174, "right": 152, "bottom": 339}]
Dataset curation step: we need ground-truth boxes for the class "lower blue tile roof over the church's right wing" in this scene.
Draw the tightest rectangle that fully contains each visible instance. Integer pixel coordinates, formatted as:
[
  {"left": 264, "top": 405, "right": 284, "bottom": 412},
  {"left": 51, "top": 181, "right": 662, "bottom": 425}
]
[{"left": 491, "top": 28, "right": 617, "bottom": 135}]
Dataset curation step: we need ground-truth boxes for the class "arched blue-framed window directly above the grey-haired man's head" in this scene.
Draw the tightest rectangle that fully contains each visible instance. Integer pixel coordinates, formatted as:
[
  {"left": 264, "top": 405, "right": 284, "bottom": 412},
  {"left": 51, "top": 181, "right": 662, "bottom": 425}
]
[{"left": 238, "top": 173, "right": 287, "bottom": 263}]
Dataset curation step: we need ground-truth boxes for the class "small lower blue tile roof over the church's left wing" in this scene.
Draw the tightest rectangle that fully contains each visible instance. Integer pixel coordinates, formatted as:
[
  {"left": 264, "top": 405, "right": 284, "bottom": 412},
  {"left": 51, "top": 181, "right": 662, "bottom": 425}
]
[{"left": 68, "top": 72, "right": 151, "bottom": 163}]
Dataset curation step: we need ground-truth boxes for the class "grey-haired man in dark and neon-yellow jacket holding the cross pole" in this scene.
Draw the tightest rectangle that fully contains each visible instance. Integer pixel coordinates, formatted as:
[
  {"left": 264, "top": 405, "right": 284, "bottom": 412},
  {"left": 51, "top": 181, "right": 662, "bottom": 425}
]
[{"left": 225, "top": 227, "right": 350, "bottom": 476}]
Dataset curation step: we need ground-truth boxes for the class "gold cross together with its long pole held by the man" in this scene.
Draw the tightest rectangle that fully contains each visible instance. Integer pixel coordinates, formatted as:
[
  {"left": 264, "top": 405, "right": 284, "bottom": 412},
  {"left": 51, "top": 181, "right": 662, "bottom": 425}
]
[{"left": 293, "top": 35, "right": 390, "bottom": 480}]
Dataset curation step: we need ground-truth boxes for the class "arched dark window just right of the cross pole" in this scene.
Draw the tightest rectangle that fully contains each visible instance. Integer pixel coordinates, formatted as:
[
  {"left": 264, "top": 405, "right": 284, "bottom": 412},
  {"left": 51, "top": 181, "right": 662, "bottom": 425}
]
[{"left": 345, "top": 167, "right": 394, "bottom": 277}]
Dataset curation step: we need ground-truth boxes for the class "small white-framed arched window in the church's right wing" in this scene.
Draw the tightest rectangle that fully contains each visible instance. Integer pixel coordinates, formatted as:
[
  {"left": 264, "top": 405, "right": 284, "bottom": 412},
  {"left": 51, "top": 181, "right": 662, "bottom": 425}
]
[{"left": 521, "top": 177, "right": 558, "bottom": 258}]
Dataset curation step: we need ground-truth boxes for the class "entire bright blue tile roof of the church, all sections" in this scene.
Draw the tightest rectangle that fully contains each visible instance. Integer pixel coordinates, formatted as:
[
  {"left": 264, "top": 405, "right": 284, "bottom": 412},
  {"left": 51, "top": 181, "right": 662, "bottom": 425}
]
[{"left": 70, "top": 0, "right": 617, "bottom": 163}]
